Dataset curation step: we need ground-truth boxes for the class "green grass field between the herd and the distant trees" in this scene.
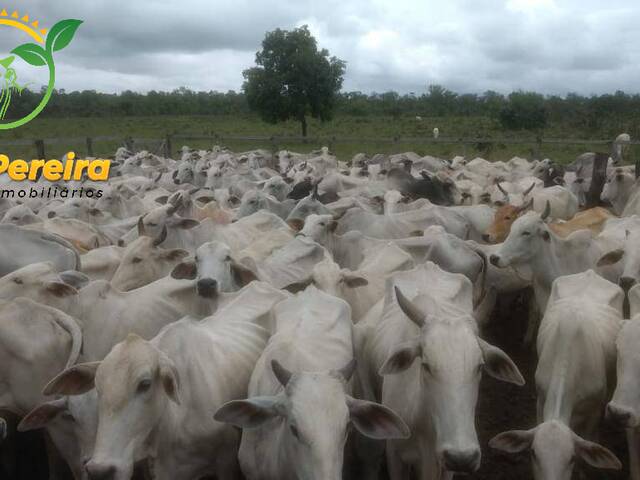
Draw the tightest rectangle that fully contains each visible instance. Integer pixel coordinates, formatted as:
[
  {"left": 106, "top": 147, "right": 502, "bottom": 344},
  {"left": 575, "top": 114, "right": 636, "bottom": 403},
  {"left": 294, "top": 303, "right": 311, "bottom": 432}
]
[{"left": 0, "top": 115, "right": 640, "bottom": 163}]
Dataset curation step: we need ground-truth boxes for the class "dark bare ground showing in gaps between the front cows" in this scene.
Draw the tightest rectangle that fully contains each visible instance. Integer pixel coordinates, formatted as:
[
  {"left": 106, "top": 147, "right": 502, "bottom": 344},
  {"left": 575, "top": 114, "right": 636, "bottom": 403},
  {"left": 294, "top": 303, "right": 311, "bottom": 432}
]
[{"left": 0, "top": 290, "right": 628, "bottom": 480}]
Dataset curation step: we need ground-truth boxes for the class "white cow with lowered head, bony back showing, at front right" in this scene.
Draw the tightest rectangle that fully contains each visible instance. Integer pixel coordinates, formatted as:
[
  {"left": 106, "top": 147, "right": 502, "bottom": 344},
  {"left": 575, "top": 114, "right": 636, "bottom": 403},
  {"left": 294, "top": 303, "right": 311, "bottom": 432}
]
[{"left": 490, "top": 270, "right": 624, "bottom": 480}]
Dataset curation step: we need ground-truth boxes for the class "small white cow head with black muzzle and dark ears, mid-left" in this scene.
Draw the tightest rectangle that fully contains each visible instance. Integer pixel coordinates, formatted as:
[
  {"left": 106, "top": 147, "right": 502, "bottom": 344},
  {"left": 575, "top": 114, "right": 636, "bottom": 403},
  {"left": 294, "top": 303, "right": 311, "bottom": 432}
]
[{"left": 171, "top": 242, "right": 257, "bottom": 298}]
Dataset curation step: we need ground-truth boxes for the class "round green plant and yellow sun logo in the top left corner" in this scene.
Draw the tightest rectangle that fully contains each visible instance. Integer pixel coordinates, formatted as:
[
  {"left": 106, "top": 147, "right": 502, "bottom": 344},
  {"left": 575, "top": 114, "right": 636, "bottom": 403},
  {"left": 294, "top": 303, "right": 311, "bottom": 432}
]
[{"left": 0, "top": 10, "right": 82, "bottom": 130}]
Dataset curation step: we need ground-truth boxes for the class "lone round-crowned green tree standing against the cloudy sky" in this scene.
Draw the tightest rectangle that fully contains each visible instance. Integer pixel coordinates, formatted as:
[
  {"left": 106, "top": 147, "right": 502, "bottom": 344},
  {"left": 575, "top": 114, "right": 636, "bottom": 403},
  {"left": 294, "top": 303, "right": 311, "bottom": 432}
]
[{"left": 242, "top": 25, "right": 346, "bottom": 137}]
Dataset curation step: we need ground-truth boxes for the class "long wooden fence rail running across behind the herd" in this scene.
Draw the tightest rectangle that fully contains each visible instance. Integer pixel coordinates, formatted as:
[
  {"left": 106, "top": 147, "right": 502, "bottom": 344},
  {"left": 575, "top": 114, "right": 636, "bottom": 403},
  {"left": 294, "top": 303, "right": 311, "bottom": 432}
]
[{"left": 0, "top": 134, "right": 640, "bottom": 158}]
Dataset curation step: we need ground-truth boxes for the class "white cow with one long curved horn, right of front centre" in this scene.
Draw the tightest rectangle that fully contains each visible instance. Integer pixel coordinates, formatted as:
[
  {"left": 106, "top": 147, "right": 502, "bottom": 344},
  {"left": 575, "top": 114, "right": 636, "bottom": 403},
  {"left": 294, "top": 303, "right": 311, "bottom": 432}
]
[{"left": 356, "top": 262, "right": 524, "bottom": 480}]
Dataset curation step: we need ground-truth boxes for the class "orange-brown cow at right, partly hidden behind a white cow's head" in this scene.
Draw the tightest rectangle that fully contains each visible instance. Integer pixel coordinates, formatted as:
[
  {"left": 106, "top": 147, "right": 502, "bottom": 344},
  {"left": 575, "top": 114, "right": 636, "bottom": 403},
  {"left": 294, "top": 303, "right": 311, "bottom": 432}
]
[{"left": 482, "top": 203, "right": 615, "bottom": 243}]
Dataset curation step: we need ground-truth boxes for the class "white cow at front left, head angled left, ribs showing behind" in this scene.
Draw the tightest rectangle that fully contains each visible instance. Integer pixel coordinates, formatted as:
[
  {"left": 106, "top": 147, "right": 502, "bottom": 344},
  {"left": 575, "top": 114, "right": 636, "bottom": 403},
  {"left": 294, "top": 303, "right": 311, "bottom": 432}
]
[{"left": 41, "top": 288, "right": 282, "bottom": 480}]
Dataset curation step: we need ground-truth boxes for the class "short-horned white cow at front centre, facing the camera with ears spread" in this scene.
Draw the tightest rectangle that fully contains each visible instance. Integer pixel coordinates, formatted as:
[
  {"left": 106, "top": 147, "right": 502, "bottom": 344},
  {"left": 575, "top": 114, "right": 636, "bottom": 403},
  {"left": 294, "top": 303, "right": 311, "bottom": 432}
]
[{"left": 215, "top": 287, "right": 409, "bottom": 480}]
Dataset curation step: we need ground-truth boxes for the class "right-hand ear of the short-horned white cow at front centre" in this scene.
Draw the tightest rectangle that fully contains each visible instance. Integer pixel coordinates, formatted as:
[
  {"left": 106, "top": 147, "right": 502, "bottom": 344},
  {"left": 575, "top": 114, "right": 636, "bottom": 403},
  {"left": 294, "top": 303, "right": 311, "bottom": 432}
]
[{"left": 347, "top": 397, "right": 411, "bottom": 440}]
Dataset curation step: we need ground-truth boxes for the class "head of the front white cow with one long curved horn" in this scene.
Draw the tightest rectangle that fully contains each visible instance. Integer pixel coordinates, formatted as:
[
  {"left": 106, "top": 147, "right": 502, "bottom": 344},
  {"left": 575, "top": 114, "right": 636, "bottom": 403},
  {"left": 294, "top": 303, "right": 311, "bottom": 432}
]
[{"left": 379, "top": 287, "right": 524, "bottom": 473}]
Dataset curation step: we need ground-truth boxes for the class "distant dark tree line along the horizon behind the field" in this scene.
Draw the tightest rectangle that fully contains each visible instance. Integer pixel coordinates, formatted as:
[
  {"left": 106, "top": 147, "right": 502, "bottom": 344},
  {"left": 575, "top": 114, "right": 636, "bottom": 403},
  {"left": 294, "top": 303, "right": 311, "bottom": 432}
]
[{"left": 7, "top": 85, "right": 640, "bottom": 137}]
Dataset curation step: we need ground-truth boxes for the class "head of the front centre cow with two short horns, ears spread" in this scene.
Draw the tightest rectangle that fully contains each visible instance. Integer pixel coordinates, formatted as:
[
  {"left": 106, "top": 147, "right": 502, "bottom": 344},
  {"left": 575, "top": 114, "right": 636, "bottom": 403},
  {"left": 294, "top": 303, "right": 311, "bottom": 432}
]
[{"left": 214, "top": 360, "right": 409, "bottom": 480}]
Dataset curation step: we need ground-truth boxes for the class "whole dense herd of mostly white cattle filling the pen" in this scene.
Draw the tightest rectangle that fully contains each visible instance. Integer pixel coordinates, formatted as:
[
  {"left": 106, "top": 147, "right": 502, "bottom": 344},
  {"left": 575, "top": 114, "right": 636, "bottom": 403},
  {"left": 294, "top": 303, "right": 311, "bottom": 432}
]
[{"left": 0, "top": 140, "right": 640, "bottom": 480}]
